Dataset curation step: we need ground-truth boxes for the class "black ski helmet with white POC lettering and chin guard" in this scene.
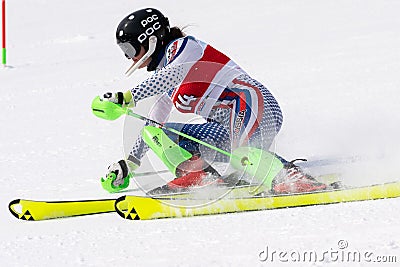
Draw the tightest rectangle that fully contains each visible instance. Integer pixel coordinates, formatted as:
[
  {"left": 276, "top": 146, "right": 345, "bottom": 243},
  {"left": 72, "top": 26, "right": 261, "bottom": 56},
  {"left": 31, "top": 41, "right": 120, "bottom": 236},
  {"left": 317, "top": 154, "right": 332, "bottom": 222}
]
[{"left": 116, "top": 8, "right": 170, "bottom": 71}]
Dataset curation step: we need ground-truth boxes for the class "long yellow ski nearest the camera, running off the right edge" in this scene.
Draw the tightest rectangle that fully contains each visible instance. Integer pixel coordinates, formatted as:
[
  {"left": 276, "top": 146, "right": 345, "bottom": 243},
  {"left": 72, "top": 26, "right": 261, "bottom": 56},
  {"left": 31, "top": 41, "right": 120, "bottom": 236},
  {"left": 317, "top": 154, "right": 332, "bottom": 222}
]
[{"left": 115, "top": 182, "right": 400, "bottom": 220}]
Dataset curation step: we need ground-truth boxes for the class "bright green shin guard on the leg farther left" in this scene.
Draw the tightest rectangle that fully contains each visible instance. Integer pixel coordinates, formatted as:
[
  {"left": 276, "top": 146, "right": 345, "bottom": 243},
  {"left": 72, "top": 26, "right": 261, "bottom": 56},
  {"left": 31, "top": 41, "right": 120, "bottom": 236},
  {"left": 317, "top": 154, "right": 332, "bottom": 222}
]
[{"left": 142, "top": 126, "right": 192, "bottom": 175}]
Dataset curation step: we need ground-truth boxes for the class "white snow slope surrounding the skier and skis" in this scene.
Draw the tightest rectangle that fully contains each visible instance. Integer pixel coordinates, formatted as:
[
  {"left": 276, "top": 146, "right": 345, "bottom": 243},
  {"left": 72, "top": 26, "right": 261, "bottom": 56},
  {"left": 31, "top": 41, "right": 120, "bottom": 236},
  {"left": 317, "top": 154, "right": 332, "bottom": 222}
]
[{"left": 0, "top": 0, "right": 400, "bottom": 266}]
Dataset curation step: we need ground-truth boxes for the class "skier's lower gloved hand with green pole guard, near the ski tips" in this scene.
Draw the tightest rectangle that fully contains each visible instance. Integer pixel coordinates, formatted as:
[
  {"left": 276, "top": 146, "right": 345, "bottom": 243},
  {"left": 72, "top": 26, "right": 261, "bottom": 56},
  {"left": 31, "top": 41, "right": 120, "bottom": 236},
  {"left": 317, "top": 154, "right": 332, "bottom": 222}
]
[{"left": 101, "top": 160, "right": 139, "bottom": 193}]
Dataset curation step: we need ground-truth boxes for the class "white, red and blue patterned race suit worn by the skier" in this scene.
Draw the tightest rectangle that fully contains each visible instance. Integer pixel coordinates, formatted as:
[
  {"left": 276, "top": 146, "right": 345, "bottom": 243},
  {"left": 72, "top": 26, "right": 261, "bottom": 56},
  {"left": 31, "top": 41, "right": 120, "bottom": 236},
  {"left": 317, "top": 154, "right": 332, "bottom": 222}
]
[{"left": 129, "top": 36, "right": 282, "bottom": 163}]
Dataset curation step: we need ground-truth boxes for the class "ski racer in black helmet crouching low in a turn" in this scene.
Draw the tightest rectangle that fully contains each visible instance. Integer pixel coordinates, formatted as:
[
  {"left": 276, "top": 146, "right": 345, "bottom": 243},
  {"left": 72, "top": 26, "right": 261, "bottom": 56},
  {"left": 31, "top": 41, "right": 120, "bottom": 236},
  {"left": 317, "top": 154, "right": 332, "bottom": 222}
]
[{"left": 95, "top": 8, "right": 326, "bottom": 194}]
